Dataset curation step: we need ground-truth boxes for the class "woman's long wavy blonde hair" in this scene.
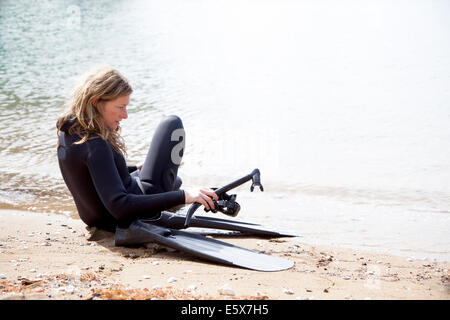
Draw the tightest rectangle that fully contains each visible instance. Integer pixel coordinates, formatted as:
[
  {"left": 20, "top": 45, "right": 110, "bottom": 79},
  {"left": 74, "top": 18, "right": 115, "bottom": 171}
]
[{"left": 57, "top": 67, "right": 133, "bottom": 155}]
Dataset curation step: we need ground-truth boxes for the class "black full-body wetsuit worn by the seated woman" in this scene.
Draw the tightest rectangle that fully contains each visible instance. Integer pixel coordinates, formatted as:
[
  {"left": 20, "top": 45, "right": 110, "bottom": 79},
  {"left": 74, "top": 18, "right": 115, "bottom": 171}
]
[{"left": 58, "top": 116, "right": 185, "bottom": 230}]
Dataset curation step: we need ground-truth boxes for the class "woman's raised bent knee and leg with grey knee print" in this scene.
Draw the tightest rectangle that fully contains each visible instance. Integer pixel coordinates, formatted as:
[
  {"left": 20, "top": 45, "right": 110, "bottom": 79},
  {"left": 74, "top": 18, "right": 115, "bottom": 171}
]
[{"left": 139, "top": 115, "right": 186, "bottom": 193}]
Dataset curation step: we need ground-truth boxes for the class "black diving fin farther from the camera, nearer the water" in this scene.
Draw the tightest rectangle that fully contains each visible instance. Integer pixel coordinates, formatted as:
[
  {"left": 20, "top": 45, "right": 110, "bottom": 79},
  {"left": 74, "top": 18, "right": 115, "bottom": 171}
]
[{"left": 148, "top": 211, "right": 297, "bottom": 238}]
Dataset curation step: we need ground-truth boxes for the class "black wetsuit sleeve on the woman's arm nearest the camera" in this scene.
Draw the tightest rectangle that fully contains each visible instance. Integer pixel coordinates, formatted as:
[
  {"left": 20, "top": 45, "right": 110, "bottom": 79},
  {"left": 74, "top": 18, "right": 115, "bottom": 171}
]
[{"left": 86, "top": 139, "right": 184, "bottom": 222}]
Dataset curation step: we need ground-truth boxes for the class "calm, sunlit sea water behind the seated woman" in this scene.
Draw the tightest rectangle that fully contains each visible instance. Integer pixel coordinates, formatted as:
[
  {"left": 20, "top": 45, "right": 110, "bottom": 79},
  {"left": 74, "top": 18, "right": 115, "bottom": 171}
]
[{"left": 0, "top": 0, "right": 450, "bottom": 261}]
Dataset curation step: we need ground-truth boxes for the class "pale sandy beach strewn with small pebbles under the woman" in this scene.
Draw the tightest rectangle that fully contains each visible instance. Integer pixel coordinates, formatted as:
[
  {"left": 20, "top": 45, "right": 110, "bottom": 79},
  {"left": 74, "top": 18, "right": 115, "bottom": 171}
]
[{"left": 0, "top": 210, "right": 450, "bottom": 300}]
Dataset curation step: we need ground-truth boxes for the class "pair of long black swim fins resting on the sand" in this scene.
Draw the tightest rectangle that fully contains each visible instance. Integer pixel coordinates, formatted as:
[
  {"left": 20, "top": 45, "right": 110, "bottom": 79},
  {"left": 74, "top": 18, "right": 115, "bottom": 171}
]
[{"left": 115, "top": 211, "right": 295, "bottom": 271}]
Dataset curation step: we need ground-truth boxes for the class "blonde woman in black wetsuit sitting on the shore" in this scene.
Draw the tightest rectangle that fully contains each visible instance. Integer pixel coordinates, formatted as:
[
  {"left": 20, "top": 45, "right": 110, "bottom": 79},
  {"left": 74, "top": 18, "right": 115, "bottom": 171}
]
[{"left": 57, "top": 68, "right": 217, "bottom": 231}]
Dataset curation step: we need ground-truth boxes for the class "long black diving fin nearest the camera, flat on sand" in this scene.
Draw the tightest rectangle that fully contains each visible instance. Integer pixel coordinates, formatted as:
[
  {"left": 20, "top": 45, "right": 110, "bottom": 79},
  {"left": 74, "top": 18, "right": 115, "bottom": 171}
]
[{"left": 115, "top": 219, "right": 294, "bottom": 271}]
